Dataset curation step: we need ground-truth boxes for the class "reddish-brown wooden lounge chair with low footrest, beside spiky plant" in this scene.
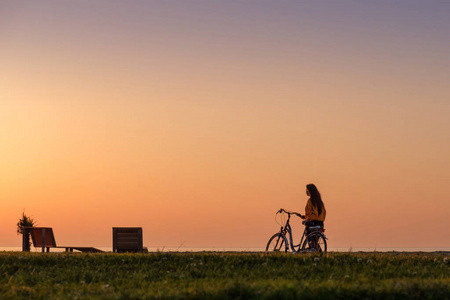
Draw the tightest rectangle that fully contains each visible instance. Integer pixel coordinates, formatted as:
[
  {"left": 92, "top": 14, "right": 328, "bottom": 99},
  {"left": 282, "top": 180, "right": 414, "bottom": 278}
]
[{"left": 24, "top": 227, "right": 104, "bottom": 253}]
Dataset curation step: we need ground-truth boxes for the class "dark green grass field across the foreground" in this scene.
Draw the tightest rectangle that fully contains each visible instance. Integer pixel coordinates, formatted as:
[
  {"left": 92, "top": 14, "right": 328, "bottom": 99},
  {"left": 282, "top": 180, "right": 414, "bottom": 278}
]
[{"left": 0, "top": 252, "right": 450, "bottom": 300}]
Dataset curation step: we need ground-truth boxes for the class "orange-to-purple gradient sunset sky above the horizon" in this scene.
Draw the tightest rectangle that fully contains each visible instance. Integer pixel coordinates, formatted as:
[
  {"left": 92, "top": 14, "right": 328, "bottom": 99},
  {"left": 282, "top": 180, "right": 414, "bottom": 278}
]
[{"left": 0, "top": 0, "right": 450, "bottom": 248}]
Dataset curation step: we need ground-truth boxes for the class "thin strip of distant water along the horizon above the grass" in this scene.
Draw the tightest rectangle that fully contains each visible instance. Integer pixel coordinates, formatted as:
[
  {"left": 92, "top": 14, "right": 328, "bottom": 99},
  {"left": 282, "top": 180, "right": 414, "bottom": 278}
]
[{"left": 0, "top": 246, "right": 450, "bottom": 252}]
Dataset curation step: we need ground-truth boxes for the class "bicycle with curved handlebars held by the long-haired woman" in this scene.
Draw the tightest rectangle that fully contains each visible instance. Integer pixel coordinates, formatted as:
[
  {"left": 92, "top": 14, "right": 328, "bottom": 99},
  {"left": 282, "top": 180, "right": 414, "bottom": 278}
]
[{"left": 266, "top": 208, "right": 327, "bottom": 253}]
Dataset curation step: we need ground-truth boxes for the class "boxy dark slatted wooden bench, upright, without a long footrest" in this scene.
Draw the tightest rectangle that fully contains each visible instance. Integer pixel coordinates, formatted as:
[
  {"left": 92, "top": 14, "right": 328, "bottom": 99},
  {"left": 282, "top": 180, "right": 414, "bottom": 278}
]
[{"left": 113, "top": 227, "right": 148, "bottom": 253}]
